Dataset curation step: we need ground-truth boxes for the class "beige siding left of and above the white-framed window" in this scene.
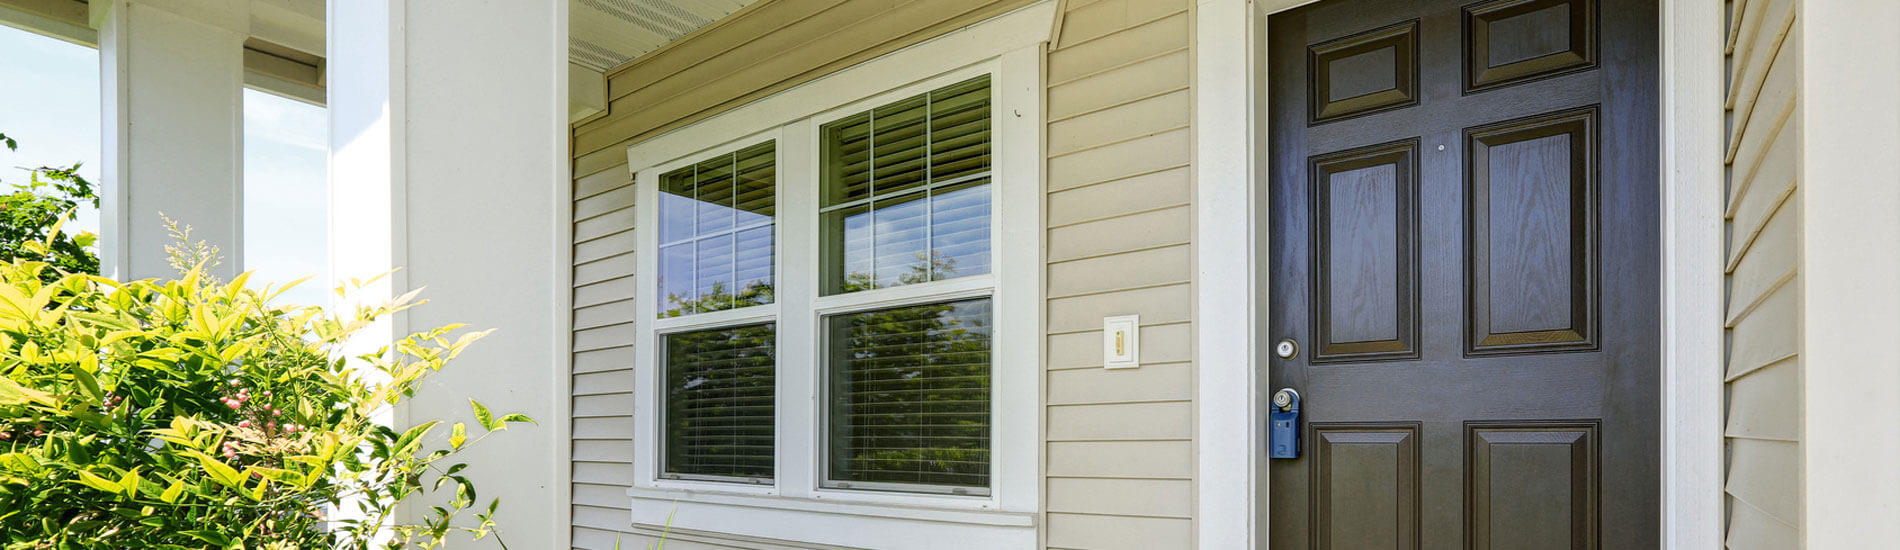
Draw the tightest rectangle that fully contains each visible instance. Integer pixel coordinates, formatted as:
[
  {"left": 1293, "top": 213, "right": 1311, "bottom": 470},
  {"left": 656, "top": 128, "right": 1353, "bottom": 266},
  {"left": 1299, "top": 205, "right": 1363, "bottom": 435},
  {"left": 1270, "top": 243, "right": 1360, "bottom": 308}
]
[{"left": 572, "top": 0, "right": 1034, "bottom": 550}]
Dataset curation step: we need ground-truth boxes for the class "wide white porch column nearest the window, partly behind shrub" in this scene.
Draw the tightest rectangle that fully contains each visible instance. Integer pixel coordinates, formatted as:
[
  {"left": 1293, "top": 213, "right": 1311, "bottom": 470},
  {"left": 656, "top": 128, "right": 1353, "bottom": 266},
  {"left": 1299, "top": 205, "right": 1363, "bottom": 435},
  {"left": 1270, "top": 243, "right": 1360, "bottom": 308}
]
[{"left": 327, "top": 0, "right": 570, "bottom": 548}]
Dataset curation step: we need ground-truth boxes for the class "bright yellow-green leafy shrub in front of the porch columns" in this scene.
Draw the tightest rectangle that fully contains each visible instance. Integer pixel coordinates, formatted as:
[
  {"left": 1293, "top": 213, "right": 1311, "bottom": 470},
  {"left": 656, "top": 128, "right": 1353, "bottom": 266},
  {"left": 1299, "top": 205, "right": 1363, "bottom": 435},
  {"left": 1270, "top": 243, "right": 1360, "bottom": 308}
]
[{"left": 0, "top": 228, "right": 528, "bottom": 548}]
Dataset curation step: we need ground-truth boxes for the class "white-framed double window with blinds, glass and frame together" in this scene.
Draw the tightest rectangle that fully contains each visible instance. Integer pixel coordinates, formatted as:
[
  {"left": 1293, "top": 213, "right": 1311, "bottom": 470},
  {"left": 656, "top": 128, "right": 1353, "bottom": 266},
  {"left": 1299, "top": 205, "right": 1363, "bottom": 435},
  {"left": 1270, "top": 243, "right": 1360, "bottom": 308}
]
[{"left": 629, "top": 26, "right": 1041, "bottom": 540}]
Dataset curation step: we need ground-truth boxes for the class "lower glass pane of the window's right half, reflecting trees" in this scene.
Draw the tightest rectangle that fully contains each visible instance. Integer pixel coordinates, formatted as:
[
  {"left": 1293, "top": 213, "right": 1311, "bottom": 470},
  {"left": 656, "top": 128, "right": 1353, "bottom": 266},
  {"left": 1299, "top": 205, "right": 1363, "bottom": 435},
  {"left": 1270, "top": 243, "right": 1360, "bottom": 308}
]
[{"left": 827, "top": 299, "right": 990, "bottom": 495}]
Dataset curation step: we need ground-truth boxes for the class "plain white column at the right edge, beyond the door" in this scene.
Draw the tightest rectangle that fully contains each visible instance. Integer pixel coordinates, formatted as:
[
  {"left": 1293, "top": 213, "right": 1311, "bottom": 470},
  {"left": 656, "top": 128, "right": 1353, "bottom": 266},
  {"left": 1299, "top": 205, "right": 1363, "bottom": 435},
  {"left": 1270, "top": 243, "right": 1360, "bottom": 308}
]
[{"left": 1790, "top": 0, "right": 1900, "bottom": 548}]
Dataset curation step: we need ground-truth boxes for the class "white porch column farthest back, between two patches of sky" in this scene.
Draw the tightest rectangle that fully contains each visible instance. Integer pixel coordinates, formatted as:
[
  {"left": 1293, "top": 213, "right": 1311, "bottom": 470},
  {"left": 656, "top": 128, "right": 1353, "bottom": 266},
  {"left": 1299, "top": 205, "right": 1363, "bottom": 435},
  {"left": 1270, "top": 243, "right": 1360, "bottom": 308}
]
[{"left": 95, "top": 0, "right": 249, "bottom": 280}]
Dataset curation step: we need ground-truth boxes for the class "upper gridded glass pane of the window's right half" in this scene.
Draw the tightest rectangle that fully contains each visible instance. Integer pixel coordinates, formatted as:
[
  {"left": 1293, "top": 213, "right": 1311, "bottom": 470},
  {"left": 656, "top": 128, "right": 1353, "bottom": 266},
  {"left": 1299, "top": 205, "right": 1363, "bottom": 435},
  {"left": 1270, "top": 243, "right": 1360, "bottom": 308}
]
[{"left": 819, "top": 76, "right": 990, "bottom": 295}]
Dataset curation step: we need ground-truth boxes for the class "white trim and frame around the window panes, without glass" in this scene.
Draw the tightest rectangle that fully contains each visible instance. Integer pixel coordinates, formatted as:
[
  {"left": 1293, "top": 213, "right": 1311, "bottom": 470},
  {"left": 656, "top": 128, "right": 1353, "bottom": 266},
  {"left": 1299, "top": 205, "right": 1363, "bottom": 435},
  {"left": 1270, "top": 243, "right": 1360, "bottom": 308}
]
[{"left": 627, "top": 0, "right": 1055, "bottom": 548}]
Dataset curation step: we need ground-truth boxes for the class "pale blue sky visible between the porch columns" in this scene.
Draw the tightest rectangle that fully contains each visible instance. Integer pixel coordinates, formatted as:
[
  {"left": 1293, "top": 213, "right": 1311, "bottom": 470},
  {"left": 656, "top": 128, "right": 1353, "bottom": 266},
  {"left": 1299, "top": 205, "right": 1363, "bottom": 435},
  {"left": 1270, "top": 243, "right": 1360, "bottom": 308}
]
[{"left": 0, "top": 27, "right": 331, "bottom": 304}]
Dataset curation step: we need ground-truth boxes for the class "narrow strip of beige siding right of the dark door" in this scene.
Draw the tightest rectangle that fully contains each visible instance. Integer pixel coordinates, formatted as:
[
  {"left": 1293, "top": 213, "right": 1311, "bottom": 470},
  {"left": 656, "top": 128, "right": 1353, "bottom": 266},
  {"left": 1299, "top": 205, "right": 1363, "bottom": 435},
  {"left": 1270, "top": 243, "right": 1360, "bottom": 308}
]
[{"left": 1725, "top": 0, "right": 1801, "bottom": 550}]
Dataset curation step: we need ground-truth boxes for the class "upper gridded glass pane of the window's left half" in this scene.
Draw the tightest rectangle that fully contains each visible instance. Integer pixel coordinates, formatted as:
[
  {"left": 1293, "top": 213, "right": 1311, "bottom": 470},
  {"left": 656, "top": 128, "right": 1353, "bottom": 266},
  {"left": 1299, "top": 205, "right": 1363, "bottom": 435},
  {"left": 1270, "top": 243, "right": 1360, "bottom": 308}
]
[{"left": 659, "top": 141, "right": 777, "bottom": 318}]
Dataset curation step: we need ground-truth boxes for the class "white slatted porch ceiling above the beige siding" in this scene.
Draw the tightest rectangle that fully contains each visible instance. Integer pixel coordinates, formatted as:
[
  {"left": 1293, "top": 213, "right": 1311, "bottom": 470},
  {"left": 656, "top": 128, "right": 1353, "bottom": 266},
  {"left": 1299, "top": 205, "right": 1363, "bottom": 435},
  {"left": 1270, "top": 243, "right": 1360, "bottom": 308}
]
[{"left": 568, "top": 0, "right": 758, "bottom": 72}]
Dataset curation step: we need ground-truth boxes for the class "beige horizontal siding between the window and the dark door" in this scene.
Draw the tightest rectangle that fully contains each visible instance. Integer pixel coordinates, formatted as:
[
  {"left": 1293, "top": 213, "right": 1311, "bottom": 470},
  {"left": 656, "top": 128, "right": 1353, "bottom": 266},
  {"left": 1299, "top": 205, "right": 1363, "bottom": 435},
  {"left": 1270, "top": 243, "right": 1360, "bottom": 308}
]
[{"left": 1043, "top": 0, "right": 1193, "bottom": 548}]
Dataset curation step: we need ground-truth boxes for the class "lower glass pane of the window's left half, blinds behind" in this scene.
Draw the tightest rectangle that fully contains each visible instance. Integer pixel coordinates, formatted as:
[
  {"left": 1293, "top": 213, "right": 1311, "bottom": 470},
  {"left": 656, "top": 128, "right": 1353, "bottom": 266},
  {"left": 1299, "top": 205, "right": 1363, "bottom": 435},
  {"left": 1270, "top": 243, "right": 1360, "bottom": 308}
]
[{"left": 663, "top": 324, "right": 775, "bottom": 478}]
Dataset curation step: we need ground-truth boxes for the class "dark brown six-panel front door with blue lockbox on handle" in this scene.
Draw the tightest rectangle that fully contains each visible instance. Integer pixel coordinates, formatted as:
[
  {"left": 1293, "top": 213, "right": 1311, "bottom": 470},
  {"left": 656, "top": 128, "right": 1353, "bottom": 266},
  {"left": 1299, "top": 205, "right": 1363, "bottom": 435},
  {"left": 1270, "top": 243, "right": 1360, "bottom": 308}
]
[{"left": 1265, "top": 0, "right": 1661, "bottom": 550}]
